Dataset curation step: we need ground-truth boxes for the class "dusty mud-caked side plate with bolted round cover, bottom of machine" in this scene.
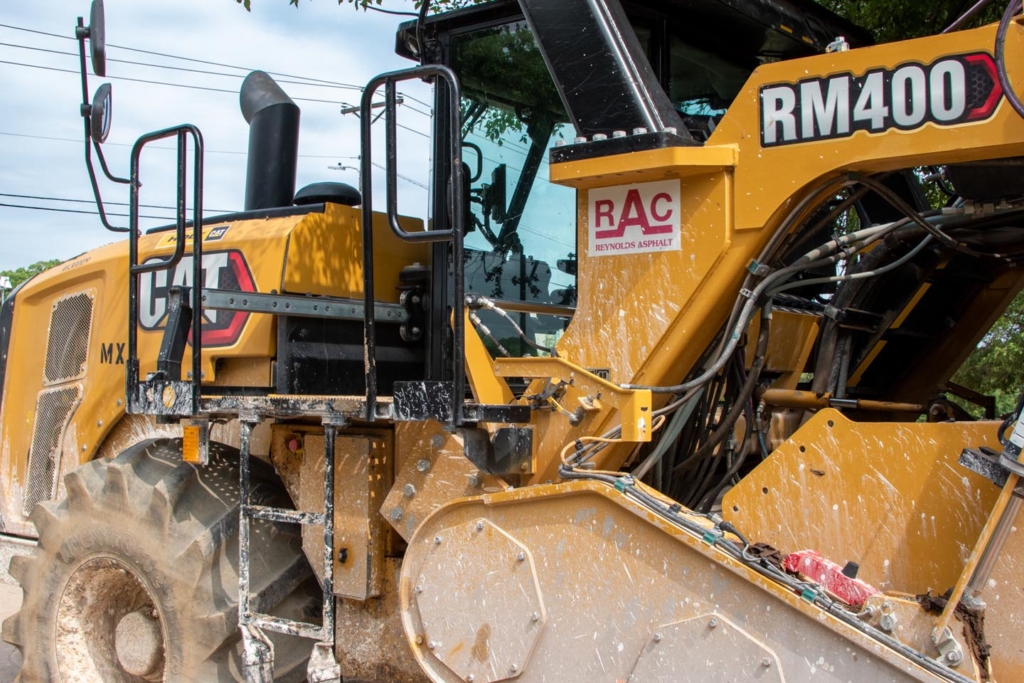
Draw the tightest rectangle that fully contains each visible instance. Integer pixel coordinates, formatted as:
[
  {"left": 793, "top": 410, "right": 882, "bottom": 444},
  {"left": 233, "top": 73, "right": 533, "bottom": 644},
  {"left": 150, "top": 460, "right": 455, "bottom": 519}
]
[{"left": 399, "top": 481, "right": 939, "bottom": 683}]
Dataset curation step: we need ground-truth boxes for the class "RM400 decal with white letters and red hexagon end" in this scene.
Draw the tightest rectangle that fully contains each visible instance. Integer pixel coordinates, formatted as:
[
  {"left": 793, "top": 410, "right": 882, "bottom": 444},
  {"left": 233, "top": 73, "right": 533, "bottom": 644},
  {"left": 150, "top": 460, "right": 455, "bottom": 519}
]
[{"left": 761, "top": 52, "right": 1002, "bottom": 147}]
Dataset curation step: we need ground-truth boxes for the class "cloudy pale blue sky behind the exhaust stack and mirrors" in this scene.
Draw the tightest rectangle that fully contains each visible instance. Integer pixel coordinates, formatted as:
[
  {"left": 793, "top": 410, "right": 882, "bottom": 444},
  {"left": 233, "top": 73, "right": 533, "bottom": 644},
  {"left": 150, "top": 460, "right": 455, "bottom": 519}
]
[{"left": 0, "top": 0, "right": 431, "bottom": 270}]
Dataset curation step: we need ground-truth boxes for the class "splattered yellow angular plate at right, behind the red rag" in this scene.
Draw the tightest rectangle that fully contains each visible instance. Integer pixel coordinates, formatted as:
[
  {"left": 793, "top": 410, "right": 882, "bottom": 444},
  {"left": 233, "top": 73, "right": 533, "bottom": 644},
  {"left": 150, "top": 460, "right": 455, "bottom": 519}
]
[{"left": 722, "top": 409, "right": 999, "bottom": 593}]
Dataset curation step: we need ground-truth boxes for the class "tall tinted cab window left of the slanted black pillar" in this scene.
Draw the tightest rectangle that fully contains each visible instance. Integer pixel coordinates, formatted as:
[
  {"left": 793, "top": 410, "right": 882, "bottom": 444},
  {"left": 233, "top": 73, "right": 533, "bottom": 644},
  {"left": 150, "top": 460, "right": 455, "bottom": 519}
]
[{"left": 451, "top": 22, "right": 577, "bottom": 355}]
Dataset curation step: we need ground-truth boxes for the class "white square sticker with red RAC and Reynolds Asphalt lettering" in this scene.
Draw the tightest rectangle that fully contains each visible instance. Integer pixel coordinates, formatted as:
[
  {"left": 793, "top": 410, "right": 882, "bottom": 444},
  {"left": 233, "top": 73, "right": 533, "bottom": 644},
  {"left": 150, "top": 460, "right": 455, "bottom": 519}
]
[{"left": 590, "top": 180, "right": 682, "bottom": 256}]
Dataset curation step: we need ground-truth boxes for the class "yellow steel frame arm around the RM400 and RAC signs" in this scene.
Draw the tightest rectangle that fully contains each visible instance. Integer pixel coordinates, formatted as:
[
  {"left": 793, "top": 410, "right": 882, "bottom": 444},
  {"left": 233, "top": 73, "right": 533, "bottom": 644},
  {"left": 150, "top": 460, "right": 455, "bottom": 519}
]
[{"left": 535, "top": 26, "right": 1024, "bottom": 482}]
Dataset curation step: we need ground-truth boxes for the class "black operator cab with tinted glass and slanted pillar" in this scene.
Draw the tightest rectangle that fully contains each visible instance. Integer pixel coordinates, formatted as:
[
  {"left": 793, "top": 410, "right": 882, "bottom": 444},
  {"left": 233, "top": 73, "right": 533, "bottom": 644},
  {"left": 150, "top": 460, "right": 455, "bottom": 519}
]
[{"left": 396, "top": 0, "right": 870, "bottom": 355}]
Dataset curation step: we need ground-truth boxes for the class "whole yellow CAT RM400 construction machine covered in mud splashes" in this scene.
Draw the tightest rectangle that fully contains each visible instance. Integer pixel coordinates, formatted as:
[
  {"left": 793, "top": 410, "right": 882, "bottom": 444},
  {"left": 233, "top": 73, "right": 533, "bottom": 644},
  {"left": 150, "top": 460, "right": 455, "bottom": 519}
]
[{"left": 0, "top": 0, "right": 1024, "bottom": 683}]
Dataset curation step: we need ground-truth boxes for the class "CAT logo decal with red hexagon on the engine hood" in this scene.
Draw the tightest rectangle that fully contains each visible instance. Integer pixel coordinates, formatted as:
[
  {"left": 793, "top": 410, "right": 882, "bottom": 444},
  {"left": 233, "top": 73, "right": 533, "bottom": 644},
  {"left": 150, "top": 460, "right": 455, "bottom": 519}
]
[{"left": 138, "top": 250, "right": 256, "bottom": 346}]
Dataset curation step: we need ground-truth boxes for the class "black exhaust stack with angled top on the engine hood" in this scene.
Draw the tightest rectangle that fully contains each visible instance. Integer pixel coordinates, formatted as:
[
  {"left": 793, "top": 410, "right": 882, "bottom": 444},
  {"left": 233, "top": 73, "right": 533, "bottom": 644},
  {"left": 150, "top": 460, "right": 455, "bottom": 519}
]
[{"left": 239, "top": 71, "right": 299, "bottom": 211}]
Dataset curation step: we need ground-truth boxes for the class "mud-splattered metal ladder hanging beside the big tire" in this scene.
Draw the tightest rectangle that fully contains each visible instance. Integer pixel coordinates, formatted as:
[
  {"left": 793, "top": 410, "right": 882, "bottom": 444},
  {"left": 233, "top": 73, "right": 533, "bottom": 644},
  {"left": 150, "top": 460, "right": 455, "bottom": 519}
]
[{"left": 239, "top": 415, "right": 341, "bottom": 683}]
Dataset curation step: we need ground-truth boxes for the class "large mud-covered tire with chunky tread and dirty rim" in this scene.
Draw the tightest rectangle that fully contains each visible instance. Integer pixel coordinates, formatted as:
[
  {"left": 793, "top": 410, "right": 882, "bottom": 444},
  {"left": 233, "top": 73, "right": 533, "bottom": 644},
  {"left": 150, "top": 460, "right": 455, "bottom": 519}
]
[{"left": 3, "top": 439, "right": 321, "bottom": 683}]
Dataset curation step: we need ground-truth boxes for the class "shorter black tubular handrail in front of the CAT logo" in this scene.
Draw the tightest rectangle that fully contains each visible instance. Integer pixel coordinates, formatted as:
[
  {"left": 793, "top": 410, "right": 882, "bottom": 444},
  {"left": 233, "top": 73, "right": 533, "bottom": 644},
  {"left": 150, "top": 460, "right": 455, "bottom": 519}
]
[{"left": 127, "top": 124, "right": 204, "bottom": 413}]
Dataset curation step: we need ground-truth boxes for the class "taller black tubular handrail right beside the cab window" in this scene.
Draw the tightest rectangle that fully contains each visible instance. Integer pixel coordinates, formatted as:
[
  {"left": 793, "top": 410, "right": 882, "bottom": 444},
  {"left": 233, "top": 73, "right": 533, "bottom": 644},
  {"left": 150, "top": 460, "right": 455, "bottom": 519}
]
[{"left": 359, "top": 65, "right": 466, "bottom": 425}]
